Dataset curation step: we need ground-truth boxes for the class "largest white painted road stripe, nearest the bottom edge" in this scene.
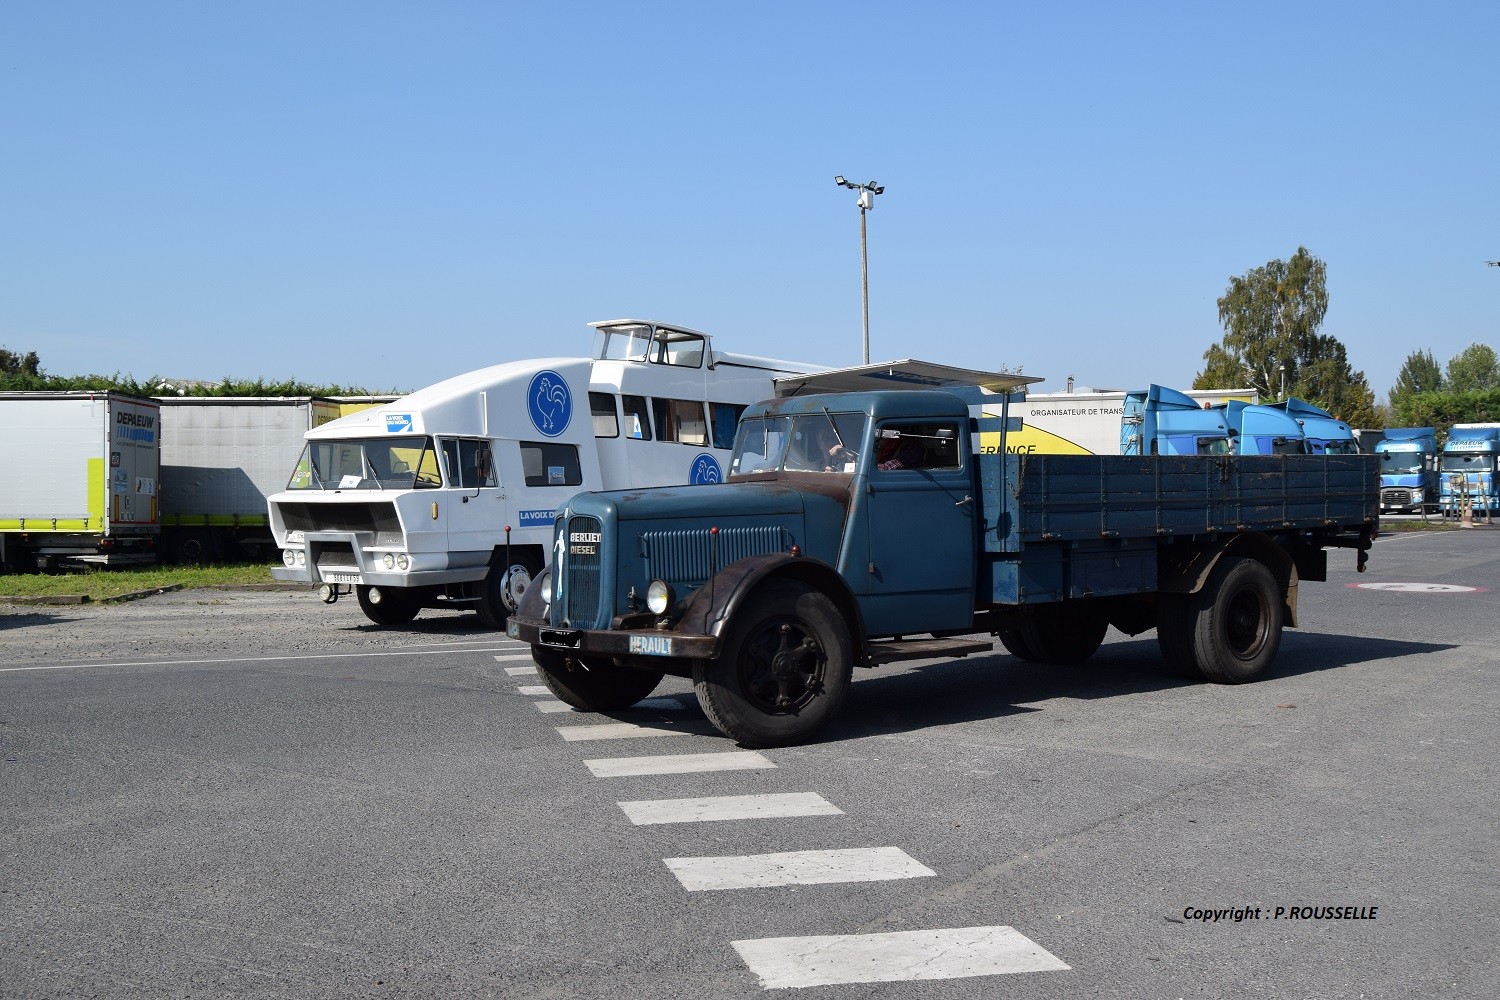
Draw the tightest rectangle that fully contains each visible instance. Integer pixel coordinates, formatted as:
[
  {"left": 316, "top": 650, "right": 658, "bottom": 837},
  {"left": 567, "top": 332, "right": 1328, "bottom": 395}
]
[{"left": 732, "top": 927, "right": 1068, "bottom": 990}]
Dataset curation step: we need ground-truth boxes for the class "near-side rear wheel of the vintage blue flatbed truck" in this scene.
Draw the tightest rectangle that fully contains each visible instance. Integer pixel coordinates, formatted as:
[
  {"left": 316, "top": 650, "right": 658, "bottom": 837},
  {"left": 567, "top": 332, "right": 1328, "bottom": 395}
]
[{"left": 1193, "top": 556, "right": 1286, "bottom": 684}]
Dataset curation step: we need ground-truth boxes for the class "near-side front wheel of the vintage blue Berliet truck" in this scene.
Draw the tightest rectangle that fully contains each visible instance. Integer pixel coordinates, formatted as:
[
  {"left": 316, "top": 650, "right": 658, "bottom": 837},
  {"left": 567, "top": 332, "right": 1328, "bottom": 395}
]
[{"left": 693, "top": 580, "right": 854, "bottom": 748}]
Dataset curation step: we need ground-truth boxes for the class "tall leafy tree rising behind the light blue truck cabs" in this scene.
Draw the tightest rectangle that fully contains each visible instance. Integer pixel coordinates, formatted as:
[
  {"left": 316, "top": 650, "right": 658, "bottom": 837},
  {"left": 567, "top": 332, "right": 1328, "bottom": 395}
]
[{"left": 1193, "top": 246, "right": 1376, "bottom": 426}]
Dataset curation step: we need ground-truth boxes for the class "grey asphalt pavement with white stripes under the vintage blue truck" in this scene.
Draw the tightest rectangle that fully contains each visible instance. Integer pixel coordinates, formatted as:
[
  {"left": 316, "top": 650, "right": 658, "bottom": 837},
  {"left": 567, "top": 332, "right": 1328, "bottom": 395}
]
[{"left": 0, "top": 528, "right": 1500, "bottom": 999}]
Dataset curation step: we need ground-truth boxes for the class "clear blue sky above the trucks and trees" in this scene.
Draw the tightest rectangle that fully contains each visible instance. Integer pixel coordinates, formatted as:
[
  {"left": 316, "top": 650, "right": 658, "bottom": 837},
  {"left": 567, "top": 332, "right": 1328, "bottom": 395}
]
[{"left": 0, "top": 0, "right": 1500, "bottom": 400}]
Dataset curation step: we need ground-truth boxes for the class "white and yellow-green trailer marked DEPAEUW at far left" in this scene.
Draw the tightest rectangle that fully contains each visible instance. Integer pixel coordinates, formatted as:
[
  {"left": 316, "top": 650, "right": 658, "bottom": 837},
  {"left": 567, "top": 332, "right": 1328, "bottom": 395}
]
[{"left": 0, "top": 391, "right": 162, "bottom": 570}]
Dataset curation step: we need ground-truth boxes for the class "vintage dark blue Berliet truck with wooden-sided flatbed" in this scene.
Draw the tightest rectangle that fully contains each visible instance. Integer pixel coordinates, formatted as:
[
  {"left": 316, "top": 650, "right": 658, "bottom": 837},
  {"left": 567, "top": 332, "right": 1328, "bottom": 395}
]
[{"left": 509, "top": 363, "right": 1377, "bottom": 747}]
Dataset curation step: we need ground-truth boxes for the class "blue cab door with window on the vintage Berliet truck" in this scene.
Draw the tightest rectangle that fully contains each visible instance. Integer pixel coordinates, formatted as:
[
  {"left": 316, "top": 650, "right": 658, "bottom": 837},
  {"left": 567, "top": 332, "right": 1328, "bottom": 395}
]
[{"left": 866, "top": 418, "right": 978, "bottom": 634}]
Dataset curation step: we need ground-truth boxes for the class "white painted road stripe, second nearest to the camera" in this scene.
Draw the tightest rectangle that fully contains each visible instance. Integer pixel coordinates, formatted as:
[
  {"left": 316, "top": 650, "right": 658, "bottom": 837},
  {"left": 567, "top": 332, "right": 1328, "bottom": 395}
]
[{"left": 665, "top": 847, "right": 938, "bottom": 892}]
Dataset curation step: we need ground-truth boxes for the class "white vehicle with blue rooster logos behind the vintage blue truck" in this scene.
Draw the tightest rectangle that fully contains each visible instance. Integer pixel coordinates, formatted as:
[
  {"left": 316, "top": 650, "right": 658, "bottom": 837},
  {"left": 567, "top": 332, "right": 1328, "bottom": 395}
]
[{"left": 267, "top": 319, "right": 819, "bottom": 628}]
